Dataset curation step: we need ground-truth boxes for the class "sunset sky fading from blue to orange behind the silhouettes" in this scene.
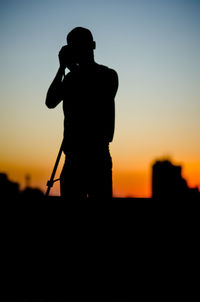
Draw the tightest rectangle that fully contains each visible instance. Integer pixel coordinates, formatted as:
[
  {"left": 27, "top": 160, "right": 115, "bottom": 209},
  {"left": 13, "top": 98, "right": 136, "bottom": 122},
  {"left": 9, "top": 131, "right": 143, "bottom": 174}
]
[{"left": 0, "top": 0, "right": 200, "bottom": 197}]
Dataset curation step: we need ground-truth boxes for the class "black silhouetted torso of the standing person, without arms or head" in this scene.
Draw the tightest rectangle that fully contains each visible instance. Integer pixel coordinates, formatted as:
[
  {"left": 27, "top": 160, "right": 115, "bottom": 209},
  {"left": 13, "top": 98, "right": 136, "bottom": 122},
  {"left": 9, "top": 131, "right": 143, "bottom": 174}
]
[{"left": 63, "top": 63, "right": 109, "bottom": 149}]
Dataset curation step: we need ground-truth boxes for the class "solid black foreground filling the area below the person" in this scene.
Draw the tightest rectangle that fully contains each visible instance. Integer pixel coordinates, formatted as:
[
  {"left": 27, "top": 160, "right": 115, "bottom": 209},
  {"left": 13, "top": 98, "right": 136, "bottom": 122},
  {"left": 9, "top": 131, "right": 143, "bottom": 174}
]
[{"left": 1, "top": 198, "right": 199, "bottom": 302}]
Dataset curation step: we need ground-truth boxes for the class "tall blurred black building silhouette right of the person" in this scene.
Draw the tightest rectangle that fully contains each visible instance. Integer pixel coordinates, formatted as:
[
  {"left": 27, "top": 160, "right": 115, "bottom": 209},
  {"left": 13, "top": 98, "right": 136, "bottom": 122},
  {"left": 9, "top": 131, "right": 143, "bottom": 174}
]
[{"left": 152, "top": 160, "right": 200, "bottom": 200}]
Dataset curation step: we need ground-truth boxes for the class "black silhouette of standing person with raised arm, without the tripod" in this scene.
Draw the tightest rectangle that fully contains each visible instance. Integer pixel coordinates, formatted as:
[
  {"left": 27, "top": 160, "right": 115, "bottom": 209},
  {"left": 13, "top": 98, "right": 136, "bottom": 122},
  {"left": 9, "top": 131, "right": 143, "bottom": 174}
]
[{"left": 46, "top": 27, "right": 118, "bottom": 200}]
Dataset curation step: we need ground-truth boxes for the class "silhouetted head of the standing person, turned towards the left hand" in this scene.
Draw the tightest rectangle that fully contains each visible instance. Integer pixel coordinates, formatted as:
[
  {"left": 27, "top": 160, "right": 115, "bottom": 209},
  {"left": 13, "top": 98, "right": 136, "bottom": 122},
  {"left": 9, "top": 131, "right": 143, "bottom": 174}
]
[{"left": 67, "top": 27, "right": 96, "bottom": 63}]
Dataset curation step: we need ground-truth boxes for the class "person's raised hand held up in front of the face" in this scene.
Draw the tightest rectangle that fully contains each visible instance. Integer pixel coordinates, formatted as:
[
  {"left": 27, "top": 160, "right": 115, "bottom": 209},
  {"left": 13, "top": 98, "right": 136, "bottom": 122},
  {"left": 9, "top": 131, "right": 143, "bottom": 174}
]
[{"left": 58, "top": 45, "right": 76, "bottom": 70}]
